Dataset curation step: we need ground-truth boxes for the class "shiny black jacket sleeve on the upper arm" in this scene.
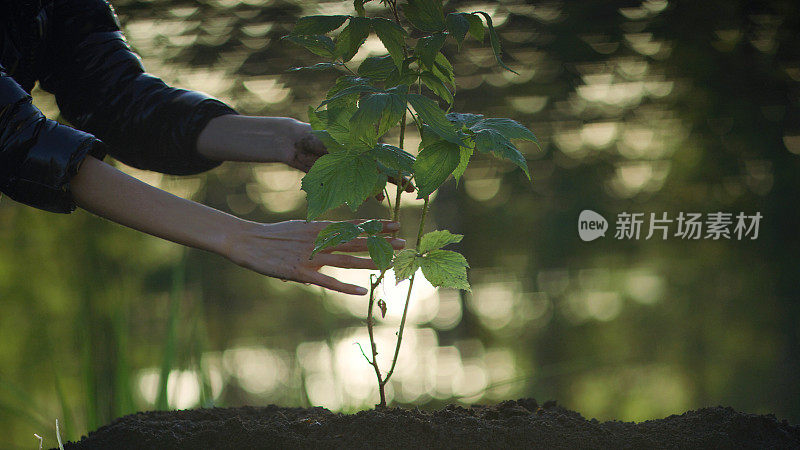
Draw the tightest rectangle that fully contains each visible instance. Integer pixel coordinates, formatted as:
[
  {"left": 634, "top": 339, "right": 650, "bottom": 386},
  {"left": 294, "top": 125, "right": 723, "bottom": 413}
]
[{"left": 40, "top": 0, "right": 236, "bottom": 175}]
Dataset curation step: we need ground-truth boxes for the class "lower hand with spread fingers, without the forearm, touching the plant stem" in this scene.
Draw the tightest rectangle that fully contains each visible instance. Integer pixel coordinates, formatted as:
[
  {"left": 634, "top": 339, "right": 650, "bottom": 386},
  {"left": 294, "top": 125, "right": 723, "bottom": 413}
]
[{"left": 226, "top": 220, "right": 405, "bottom": 295}]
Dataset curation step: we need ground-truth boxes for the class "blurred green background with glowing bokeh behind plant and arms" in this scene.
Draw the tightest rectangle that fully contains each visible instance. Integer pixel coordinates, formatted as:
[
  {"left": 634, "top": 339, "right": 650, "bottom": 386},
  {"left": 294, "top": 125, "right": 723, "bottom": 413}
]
[{"left": 0, "top": 0, "right": 800, "bottom": 448}]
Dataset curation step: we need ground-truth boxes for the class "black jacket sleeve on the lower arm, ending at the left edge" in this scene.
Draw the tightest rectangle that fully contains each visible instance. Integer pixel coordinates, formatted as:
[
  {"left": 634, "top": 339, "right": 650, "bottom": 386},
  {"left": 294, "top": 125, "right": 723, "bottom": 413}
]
[{"left": 0, "top": 66, "right": 105, "bottom": 213}]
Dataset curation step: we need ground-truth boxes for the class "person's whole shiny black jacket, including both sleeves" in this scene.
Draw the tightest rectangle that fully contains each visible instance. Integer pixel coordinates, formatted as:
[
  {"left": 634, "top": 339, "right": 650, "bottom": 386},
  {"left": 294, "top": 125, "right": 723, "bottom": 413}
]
[{"left": 0, "top": 0, "right": 236, "bottom": 213}]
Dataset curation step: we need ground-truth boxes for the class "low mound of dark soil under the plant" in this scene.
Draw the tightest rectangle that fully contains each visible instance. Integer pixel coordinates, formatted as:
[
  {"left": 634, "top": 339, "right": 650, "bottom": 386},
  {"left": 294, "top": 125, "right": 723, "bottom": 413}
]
[{"left": 65, "top": 399, "right": 800, "bottom": 450}]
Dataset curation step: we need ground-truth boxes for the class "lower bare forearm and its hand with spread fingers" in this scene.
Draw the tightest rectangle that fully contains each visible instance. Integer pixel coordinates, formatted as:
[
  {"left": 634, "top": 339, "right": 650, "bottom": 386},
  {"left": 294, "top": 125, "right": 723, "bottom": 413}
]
[{"left": 71, "top": 157, "right": 404, "bottom": 295}]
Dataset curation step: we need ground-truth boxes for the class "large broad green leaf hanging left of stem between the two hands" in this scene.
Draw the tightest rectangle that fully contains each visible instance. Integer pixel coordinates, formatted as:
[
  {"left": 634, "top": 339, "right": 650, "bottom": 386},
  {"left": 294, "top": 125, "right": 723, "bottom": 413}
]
[{"left": 302, "top": 152, "right": 378, "bottom": 220}]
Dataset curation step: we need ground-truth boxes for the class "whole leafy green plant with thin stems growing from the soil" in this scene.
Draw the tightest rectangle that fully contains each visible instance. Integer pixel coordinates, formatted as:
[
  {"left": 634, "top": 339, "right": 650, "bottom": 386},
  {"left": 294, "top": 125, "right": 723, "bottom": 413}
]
[{"left": 284, "top": 0, "right": 538, "bottom": 407}]
